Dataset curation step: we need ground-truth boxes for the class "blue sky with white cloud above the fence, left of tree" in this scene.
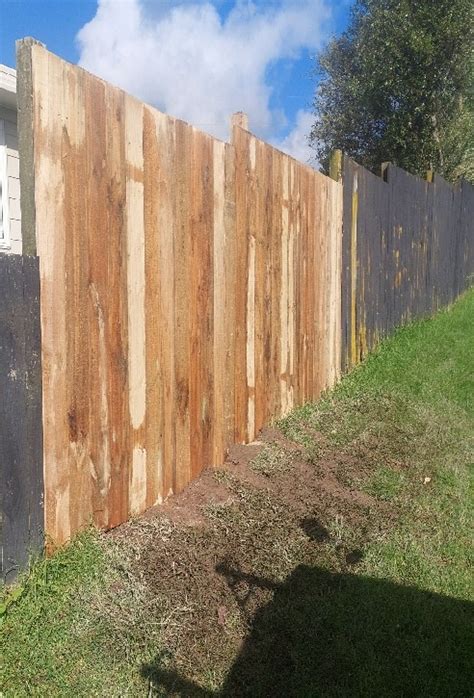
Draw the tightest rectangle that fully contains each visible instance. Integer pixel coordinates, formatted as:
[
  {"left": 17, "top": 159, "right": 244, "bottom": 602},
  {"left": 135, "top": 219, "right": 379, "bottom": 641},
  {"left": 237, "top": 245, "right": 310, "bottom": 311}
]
[{"left": 0, "top": 0, "right": 350, "bottom": 159}]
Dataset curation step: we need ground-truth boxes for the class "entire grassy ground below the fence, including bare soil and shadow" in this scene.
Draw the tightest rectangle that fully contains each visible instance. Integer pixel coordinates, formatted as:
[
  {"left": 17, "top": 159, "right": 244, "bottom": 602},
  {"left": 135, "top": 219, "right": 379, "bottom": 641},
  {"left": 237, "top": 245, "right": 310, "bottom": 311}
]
[{"left": 0, "top": 291, "right": 474, "bottom": 698}]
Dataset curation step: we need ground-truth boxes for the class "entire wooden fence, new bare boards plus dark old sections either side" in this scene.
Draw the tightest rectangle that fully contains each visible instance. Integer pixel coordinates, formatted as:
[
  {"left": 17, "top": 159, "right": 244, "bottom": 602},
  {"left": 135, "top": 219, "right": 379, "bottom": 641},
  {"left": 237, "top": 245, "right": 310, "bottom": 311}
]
[{"left": 0, "top": 40, "right": 474, "bottom": 567}]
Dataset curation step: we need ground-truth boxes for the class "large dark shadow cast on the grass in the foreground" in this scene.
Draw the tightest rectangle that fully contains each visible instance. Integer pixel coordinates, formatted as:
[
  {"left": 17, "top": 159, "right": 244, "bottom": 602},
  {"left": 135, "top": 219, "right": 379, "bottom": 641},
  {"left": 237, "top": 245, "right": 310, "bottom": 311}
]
[{"left": 142, "top": 520, "right": 474, "bottom": 698}]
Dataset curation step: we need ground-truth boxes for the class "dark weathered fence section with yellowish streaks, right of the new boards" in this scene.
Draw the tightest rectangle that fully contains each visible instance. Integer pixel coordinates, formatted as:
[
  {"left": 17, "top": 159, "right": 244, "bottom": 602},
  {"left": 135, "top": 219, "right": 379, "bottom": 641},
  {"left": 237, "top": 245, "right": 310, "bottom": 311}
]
[{"left": 342, "top": 157, "right": 474, "bottom": 368}]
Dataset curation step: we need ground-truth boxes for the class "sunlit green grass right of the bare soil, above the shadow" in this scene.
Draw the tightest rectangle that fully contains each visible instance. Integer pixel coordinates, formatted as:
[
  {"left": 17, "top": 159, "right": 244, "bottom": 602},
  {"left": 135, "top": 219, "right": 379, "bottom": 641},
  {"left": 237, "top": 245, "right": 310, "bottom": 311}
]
[{"left": 282, "top": 291, "right": 474, "bottom": 599}]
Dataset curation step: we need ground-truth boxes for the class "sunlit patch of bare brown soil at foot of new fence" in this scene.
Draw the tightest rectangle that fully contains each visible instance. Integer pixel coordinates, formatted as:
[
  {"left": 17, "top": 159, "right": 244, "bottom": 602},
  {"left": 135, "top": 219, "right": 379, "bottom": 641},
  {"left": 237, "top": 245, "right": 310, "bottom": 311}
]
[{"left": 113, "top": 422, "right": 394, "bottom": 696}]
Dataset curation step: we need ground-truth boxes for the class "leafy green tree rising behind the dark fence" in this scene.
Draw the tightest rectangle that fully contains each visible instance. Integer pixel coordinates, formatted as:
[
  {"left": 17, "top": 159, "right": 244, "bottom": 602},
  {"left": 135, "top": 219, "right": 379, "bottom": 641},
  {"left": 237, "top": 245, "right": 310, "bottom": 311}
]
[{"left": 310, "top": 0, "right": 474, "bottom": 181}]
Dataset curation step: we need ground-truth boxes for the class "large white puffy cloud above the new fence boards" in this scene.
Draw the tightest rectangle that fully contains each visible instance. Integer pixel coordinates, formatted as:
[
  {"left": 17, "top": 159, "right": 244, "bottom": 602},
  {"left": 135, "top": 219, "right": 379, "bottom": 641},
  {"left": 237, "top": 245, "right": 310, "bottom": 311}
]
[{"left": 77, "top": 0, "right": 329, "bottom": 145}]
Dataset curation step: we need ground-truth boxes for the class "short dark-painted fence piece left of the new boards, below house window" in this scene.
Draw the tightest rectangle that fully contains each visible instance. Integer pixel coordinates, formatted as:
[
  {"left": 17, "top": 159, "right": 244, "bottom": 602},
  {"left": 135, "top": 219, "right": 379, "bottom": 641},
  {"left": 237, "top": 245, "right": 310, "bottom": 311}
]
[{"left": 0, "top": 254, "right": 44, "bottom": 582}]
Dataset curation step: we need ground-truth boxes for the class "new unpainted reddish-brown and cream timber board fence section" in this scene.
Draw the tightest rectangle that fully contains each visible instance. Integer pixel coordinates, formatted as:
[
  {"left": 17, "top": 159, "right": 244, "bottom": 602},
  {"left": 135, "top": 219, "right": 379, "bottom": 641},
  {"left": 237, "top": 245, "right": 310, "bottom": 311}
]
[{"left": 18, "top": 42, "right": 342, "bottom": 543}]
